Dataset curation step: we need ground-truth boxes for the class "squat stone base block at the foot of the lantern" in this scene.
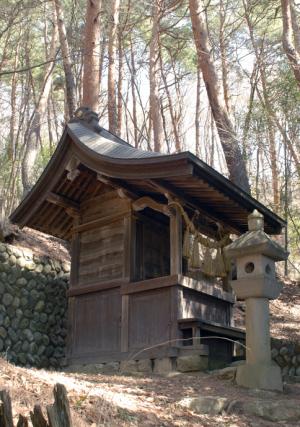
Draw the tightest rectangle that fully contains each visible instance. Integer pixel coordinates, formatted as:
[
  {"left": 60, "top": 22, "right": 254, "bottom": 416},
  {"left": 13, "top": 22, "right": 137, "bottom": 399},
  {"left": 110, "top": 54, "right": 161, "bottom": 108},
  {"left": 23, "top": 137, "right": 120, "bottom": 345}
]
[{"left": 236, "top": 363, "right": 283, "bottom": 391}]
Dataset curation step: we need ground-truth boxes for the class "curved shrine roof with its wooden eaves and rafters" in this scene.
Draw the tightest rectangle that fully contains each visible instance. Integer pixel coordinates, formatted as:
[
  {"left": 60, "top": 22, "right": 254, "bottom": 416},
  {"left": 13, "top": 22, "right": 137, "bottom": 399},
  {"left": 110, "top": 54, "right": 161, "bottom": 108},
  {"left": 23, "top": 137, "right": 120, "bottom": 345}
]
[{"left": 10, "top": 113, "right": 285, "bottom": 239}]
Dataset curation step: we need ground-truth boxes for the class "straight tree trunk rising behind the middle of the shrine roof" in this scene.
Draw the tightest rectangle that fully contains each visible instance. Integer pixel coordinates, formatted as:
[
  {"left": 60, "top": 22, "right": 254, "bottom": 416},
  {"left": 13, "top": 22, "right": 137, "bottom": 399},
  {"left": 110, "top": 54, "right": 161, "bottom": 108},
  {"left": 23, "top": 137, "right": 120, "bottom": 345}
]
[{"left": 149, "top": 0, "right": 163, "bottom": 151}]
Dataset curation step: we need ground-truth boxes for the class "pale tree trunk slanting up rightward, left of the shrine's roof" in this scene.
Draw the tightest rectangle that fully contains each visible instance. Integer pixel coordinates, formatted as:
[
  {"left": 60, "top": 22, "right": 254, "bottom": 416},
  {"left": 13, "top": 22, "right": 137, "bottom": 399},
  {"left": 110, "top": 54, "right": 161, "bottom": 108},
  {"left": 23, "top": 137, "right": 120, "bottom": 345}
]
[{"left": 22, "top": 19, "right": 58, "bottom": 194}]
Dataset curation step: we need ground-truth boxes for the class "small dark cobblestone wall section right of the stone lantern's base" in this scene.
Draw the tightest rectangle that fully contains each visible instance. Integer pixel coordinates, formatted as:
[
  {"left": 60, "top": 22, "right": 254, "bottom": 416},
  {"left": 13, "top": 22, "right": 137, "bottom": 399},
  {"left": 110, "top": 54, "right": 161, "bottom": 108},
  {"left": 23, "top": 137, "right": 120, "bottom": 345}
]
[{"left": 272, "top": 338, "right": 300, "bottom": 377}]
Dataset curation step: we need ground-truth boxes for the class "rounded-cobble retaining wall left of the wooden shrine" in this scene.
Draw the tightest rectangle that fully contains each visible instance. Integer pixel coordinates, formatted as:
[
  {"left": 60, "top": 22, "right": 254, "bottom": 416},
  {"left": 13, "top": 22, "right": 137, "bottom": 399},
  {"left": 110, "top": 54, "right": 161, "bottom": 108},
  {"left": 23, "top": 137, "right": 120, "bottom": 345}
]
[{"left": 0, "top": 243, "right": 70, "bottom": 367}]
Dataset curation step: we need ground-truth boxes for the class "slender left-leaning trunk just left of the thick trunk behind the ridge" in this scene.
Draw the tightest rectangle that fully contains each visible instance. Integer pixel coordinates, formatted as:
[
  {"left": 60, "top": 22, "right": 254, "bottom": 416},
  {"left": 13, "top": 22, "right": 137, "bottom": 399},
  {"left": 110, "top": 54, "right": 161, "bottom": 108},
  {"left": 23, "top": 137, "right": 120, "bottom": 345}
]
[{"left": 54, "top": 0, "right": 76, "bottom": 118}]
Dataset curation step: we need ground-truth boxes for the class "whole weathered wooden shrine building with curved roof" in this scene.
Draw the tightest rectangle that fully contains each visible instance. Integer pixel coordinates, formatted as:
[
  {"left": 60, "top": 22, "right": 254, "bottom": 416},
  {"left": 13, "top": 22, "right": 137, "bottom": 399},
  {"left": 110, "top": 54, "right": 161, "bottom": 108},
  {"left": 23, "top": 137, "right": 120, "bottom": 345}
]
[{"left": 11, "top": 108, "right": 285, "bottom": 363}]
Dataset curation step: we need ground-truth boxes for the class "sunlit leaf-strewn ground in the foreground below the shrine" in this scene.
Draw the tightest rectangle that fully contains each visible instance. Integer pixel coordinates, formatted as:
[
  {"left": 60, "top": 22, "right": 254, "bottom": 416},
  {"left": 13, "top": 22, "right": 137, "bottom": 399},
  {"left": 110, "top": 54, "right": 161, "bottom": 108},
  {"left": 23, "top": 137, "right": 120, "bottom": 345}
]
[{"left": 0, "top": 359, "right": 300, "bottom": 427}]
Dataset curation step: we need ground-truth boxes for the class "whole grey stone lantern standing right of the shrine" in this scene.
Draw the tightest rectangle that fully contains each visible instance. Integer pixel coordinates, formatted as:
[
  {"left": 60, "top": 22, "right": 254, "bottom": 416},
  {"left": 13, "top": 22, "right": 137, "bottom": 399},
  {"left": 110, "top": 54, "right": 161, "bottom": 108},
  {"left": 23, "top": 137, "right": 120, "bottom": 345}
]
[{"left": 225, "top": 210, "right": 288, "bottom": 390}]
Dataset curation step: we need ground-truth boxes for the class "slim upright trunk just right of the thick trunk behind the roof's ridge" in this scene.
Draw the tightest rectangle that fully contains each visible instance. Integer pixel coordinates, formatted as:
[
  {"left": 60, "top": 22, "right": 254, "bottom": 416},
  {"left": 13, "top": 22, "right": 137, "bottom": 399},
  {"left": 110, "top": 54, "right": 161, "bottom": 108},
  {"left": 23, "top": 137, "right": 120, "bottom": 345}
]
[{"left": 107, "top": 0, "right": 120, "bottom": 133}]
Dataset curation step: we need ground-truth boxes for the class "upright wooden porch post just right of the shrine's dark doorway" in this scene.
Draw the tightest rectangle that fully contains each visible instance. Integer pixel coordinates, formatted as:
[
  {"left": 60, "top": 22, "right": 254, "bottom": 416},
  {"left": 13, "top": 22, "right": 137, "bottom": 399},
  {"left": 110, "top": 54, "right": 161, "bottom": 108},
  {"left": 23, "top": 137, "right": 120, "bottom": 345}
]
[{"left": 170, "top": 209, "right": 182, "bottom": 274}]
